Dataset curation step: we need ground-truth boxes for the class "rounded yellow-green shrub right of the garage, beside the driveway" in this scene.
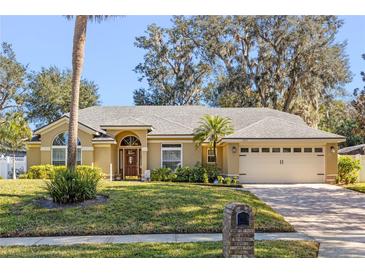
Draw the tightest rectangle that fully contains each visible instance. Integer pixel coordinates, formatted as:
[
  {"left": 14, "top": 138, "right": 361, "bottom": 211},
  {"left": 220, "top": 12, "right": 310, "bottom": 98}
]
[{"left": 336, "top": 156, "right": 361, "bottom": 184}]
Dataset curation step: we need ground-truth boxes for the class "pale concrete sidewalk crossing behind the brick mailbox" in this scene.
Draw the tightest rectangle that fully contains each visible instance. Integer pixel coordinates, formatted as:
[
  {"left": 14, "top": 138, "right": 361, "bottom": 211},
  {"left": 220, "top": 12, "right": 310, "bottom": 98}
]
[{"left": 0, "top": 232, "right": 313, "bottom": 246}]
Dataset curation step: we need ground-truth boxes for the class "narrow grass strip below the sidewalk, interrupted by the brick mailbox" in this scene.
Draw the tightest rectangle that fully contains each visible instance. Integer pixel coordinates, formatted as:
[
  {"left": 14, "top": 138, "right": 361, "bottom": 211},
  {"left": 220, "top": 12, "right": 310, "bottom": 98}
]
[{"left": 0, "top": 241, "right": 319, "bottom": 258}]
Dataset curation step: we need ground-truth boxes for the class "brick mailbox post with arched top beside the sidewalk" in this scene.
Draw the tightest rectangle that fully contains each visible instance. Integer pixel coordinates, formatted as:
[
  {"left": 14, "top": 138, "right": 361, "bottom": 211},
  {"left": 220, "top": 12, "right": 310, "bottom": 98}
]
[{"left": 223, "top": 203, "right": 255, "bottom": 258}]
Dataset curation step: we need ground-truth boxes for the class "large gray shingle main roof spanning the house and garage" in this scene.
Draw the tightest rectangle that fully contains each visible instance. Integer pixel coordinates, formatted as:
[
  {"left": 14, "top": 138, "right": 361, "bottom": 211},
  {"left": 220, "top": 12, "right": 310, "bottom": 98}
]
[{"left": 61, "top": 106, "right": 343, "bottom": 138}]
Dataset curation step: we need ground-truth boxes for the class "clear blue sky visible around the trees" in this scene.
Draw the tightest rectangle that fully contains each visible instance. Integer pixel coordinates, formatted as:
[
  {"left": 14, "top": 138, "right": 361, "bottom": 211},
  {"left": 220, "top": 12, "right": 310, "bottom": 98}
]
[{"left": 0, "top": 16, "right": 365, "bottom": 105}]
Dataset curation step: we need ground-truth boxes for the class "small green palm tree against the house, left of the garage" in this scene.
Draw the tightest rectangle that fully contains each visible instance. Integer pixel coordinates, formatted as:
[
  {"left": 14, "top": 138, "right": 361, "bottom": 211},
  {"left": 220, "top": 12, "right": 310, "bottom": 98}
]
[{"left": 193, "top": 114, "right": 234, "bottom": 165}]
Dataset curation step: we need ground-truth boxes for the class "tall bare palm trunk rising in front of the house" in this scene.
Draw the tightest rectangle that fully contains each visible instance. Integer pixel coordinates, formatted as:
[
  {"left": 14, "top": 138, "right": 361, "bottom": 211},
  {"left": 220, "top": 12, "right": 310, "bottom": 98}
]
[{"left": 67, "top": 15, "right": 87, "bottom": 170}]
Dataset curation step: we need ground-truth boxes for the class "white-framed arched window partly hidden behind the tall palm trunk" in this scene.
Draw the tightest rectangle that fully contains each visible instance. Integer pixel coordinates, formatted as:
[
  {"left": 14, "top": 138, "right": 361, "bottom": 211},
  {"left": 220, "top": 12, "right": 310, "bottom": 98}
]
[{"left": 52, "top": 132, "right": 81, "bottom": 166}]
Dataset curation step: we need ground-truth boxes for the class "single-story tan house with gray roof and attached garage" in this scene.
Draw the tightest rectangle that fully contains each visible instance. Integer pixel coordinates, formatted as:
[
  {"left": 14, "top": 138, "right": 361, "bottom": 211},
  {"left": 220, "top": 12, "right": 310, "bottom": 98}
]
[{"left": 27, "top": 106, "right": 345, "bottom": 183}]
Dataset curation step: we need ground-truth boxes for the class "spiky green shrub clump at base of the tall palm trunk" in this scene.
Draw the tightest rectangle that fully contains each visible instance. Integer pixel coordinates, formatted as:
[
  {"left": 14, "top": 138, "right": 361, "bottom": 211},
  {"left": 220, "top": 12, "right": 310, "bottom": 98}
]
[{"left": 47, "top": 167, "right": 102, "bottom": 204}]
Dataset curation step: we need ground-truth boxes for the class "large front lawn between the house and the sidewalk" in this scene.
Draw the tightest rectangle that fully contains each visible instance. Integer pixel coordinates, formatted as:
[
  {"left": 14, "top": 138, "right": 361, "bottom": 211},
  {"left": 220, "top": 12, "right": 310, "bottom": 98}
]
[{"left": 0, "top": 180, "right": 293, "bottom": 237}]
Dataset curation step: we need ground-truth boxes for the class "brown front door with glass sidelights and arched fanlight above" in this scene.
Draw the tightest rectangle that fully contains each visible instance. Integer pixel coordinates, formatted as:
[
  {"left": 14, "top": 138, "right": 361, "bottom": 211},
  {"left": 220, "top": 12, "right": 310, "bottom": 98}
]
[{"left": 119, "top": 135, "right": 141, "bottom": 180}]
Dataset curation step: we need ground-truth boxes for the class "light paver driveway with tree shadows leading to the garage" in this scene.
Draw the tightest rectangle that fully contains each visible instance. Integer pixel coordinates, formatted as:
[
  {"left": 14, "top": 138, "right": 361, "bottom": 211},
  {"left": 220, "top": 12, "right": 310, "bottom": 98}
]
[{"left": 244, "top": 184, "right": 365, "bottom": 257}]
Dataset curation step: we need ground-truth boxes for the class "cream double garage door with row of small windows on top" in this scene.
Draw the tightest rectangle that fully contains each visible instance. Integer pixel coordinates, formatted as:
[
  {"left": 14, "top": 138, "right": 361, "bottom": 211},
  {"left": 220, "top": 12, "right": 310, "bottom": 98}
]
[{"left": 240, "top": 147, "right": 325, "bottom": 183}]
